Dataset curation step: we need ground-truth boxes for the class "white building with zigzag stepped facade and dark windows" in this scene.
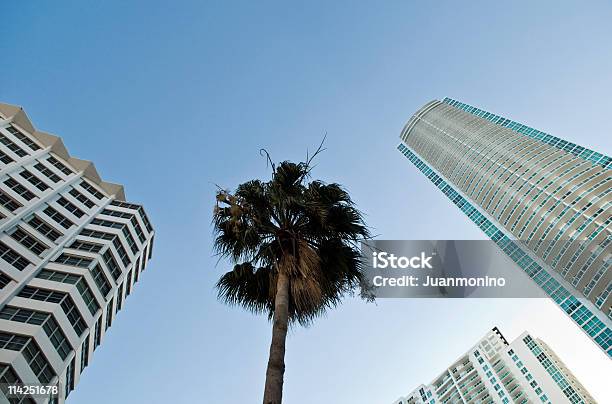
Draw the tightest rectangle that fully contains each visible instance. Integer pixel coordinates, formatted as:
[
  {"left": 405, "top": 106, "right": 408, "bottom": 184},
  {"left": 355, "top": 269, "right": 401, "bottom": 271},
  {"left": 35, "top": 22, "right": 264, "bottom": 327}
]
[{"left": 0, "top": 104, "right": 154, "bottom": 403}]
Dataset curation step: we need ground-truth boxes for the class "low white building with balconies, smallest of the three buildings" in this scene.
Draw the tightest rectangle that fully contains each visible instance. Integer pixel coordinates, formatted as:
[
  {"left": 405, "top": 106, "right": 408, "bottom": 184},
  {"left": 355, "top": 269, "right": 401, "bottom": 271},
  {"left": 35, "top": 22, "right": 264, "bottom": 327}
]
[{"left": 394, "top": 327, "right": 596, "bottom": 404}]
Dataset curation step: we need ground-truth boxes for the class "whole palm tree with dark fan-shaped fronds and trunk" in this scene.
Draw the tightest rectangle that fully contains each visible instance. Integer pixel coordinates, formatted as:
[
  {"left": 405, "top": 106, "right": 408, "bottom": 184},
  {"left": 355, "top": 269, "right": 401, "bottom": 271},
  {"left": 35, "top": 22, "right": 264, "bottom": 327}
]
[{"left": 213, "top": 147, "right": 372, "bottom": 404}]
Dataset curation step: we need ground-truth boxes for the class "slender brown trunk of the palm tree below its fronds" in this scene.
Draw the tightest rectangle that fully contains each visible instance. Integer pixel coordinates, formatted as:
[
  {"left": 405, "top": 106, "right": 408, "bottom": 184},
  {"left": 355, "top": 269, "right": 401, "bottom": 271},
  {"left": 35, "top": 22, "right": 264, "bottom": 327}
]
[{"left": 263, "top": 271, "right": 289, "bottom": 404}]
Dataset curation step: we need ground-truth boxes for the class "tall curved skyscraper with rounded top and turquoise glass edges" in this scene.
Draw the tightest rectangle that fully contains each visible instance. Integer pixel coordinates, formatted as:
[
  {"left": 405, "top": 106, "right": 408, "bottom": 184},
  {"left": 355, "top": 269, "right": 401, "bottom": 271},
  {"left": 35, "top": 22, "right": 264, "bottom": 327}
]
[{"left": 398, "top": 98, "right": 612, "bottom": 357}]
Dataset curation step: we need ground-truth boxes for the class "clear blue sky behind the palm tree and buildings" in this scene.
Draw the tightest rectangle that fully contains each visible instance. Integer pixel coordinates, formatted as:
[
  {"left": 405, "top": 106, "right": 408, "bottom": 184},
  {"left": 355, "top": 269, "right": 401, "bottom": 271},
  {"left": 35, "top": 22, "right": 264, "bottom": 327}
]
[{"left": 0, "top": 0, "right": 612, "bottom": 404}]
